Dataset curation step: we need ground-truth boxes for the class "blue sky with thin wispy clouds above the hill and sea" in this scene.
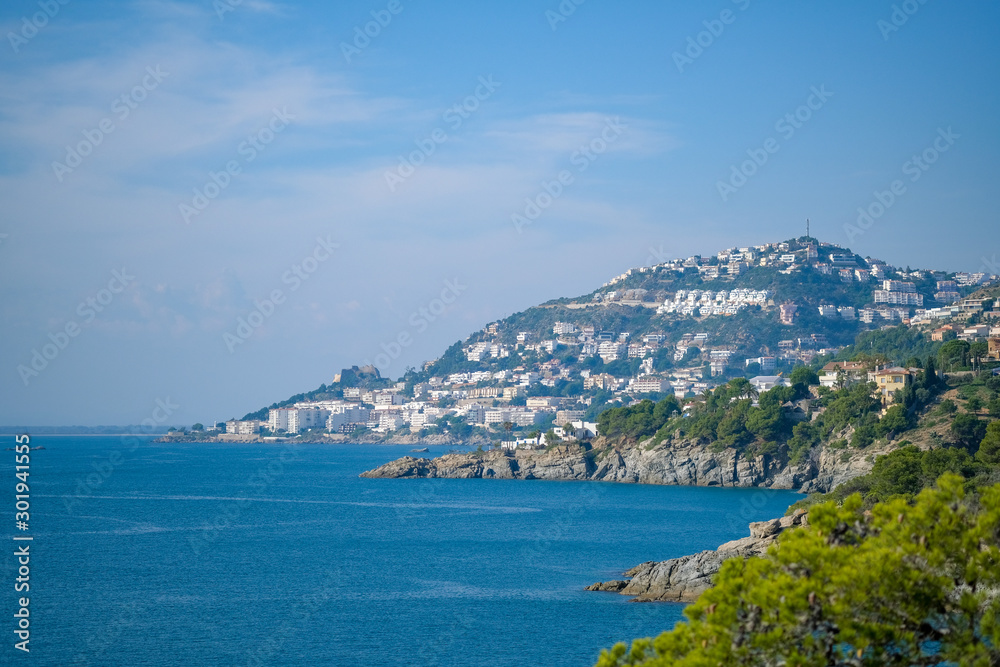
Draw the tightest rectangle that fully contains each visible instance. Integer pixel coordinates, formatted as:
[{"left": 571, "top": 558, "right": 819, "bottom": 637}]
[{"left": 0, "top": 0, "right": 1000, "bottom": 425}]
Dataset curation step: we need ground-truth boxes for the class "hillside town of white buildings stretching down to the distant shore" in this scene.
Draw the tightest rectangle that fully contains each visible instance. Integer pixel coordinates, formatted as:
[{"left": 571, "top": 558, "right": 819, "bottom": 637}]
[{"left": 197, "top": 237, "right": 1000, "bottom": 448}]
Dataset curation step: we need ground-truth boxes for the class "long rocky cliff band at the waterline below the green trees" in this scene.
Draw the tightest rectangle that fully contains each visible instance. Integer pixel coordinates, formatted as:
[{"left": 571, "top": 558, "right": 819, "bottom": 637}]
[{"left": 361, "top": 443, "right": 881, "bottom": 493}]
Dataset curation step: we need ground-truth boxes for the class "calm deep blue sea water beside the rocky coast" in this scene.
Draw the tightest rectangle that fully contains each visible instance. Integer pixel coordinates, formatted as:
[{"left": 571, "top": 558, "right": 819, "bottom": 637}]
[{"left": 0, "top": 436, "right": 798, "bottom": 666}]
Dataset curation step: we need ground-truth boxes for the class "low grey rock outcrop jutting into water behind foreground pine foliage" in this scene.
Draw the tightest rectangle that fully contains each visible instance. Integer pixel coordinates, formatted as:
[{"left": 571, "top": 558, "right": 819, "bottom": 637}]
[{"left": 586, "top": 510, "right": 807, "bottom": 602}]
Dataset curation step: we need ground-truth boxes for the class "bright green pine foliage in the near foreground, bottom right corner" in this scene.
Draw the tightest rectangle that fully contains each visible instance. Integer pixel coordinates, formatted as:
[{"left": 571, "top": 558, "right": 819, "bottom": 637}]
[{"left": 597, "top": 475, "right": 1000, "bottom": 667}]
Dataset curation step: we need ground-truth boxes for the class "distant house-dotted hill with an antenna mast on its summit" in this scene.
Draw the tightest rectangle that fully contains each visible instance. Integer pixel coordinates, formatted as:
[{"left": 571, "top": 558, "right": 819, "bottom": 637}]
[{"left": 236, "top": 237, "right": 998, "bottom": 439}]
